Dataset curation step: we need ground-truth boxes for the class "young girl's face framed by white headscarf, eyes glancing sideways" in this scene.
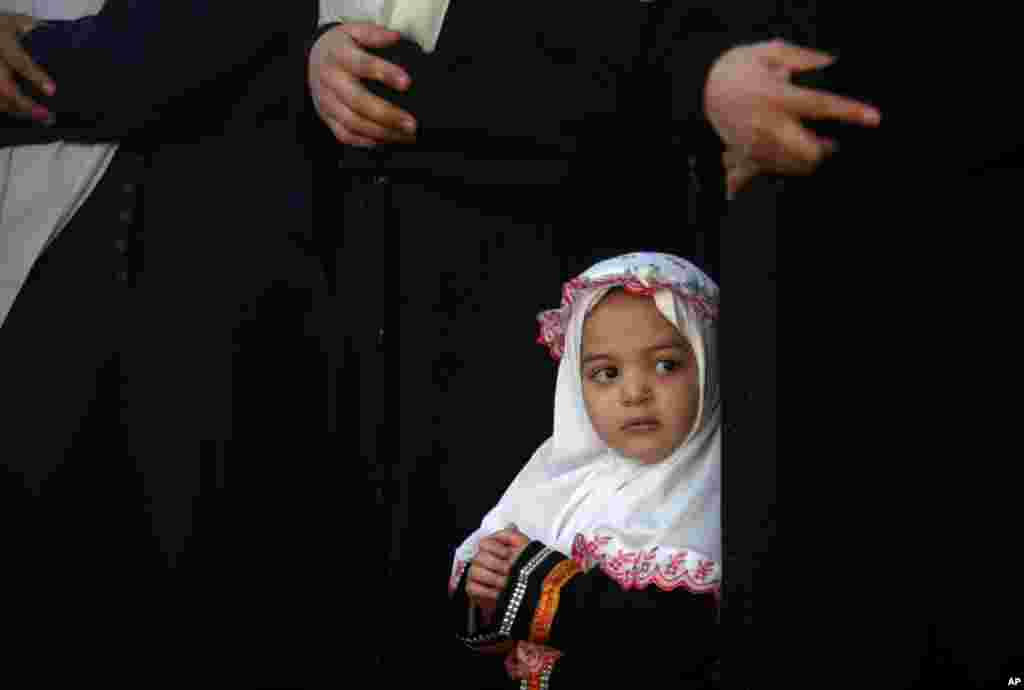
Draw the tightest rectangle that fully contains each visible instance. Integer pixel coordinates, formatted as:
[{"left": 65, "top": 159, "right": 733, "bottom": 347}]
[{"left": 581, "top": 290, "right": 700, "bottom": 464}]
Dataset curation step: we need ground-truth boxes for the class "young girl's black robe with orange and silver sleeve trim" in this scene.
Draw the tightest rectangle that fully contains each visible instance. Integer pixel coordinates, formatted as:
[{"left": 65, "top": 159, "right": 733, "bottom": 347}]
[{"left": 450, "top": 542, "right": 720, "bottom": 689}]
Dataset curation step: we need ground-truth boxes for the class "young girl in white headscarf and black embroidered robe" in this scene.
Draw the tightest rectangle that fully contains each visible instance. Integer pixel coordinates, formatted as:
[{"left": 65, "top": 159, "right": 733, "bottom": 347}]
[{"left": 449, "top": 253, "right": 722, "bottom": 689}]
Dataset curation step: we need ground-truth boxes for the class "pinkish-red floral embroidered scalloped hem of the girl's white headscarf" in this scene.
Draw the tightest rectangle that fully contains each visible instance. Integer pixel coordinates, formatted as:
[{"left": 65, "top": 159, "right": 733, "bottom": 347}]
[{"left": 572, "top": 534, "right": 721, "bottom": 597}]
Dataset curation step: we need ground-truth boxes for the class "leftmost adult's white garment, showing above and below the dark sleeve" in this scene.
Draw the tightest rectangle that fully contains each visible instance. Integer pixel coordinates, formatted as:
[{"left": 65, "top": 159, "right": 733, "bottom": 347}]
[{"left": 0, "top": 0, "right": 117, "bottom": 326}]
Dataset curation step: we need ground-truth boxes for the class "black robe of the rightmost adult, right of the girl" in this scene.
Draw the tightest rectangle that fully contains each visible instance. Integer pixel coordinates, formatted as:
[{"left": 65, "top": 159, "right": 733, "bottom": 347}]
[{"left": 722, "top": 3, "right": 1024, "bottom": 688}]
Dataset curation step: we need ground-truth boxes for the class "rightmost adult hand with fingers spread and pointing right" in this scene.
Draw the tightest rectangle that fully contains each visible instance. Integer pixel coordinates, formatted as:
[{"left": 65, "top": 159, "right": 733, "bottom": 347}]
[{"left": 705, "top": 40, "right": 882, "bottom": 186}]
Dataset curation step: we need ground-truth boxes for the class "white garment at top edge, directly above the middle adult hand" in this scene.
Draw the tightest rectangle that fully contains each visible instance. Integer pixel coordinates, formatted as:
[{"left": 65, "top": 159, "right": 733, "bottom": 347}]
[{"left": 319, "top": 0, "right": 450, "bottom": 52}]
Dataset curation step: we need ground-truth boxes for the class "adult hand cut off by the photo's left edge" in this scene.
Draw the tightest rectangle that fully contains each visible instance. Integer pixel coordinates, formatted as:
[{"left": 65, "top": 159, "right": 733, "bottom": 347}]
[{"left": 0, "top": 12, "right": 55, "bottom": 120}]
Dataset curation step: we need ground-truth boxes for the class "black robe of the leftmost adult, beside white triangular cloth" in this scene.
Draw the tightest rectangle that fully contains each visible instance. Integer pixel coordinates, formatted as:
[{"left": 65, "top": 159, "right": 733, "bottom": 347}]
[{"left": 0, "top": 0, "right": 342, "bottom": 687}]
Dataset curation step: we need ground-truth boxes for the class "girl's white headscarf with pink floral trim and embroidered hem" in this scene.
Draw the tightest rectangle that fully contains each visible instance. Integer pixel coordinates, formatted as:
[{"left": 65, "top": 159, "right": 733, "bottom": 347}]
[{"left": 451, "top": 253, "right": 722, "bottom": 594}]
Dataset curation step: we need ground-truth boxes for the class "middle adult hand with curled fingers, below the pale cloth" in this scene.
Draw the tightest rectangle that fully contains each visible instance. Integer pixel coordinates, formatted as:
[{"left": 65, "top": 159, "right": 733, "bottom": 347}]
[{"left": 307, "top": 23, "right": 416, "bottom": 146}]
